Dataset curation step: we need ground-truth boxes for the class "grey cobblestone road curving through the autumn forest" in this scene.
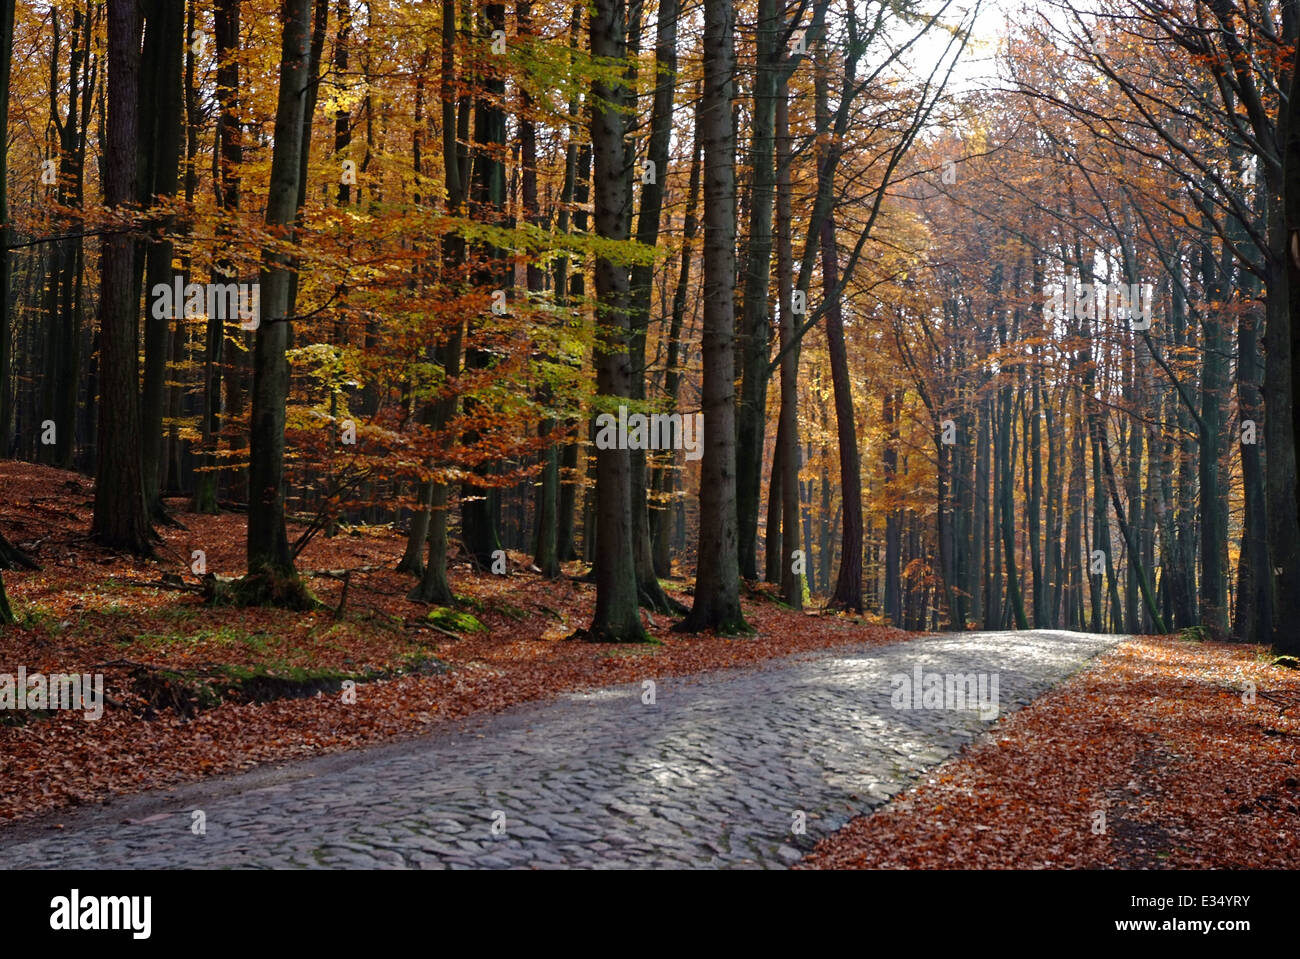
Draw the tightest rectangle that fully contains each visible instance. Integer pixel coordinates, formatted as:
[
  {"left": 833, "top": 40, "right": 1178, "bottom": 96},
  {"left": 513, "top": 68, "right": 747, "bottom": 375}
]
[{"left": 0, "top": 630, "right": 1121, "bottom": 869}]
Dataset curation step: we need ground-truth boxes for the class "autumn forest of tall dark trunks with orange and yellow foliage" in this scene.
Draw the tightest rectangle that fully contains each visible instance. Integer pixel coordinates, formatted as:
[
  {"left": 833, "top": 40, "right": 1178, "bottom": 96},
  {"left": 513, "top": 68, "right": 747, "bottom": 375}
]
[{"left": 0, "top": 0, "right": 1300, "bottom": 654}]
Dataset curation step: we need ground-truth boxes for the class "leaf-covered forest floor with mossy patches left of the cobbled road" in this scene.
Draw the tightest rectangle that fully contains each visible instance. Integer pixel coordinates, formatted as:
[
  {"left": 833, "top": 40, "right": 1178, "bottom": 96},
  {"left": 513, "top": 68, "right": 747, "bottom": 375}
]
[{"left": 0, "top": 461, "right": 911, "bottom": 821}]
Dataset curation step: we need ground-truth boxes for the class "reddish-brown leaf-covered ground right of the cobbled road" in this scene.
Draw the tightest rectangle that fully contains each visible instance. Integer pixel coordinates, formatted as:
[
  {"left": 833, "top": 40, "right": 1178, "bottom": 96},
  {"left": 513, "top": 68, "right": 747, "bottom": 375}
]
[{"left": 803, "top": 635, "right": 1300, "bottom": 869}]
